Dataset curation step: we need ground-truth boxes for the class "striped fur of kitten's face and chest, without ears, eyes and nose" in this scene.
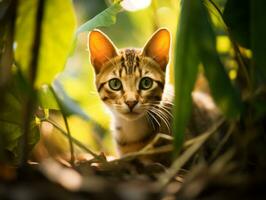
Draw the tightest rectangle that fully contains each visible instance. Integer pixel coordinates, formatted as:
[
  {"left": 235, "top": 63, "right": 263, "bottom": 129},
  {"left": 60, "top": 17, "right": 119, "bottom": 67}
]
[{"left": 96, "top": 49, "right": 169, "bottom": 155}]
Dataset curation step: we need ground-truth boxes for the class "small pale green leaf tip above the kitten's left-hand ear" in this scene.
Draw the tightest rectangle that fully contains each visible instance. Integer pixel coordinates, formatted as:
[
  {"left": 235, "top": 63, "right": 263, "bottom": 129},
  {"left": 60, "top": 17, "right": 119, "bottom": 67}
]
[{"left": 77, "top": 2, "right": 122, "bottom": 34}]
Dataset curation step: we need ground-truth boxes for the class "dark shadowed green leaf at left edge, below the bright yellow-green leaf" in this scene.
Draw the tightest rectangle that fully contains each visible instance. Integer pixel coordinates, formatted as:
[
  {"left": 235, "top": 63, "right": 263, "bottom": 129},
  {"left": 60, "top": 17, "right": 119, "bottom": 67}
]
[{"left": 0, "top": 72, "right": 39, "bottom": 164}]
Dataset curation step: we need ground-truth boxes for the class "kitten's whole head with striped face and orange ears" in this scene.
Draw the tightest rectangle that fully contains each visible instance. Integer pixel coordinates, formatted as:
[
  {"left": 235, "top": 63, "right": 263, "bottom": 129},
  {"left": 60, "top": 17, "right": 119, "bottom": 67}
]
[{"left": 88, "top": 29, "right": 170, "bottom": 120}]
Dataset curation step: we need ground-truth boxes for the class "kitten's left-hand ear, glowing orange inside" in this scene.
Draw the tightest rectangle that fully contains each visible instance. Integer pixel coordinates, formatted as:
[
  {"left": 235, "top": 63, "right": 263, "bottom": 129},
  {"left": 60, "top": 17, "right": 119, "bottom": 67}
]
[{"left": 88, "top": 30, "right": 117, "bottom": 73}]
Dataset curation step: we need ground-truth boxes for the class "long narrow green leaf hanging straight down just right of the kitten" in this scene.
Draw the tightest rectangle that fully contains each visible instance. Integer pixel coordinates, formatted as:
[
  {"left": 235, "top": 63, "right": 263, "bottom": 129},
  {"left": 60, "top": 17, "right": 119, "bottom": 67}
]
[{"left": 173, "top": 0, "right": 199, "bottom": 152}]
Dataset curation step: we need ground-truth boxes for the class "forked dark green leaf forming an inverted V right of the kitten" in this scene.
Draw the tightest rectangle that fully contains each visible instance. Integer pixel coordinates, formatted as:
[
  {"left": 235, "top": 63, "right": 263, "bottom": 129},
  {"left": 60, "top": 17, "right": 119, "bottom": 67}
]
[{"left": 173, "top": 0, "right": 242, "bottom": 152}]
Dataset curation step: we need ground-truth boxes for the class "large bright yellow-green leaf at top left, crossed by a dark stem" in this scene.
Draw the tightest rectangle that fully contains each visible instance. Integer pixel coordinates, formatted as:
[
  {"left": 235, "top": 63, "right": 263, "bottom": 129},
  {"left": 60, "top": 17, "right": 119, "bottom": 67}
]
[{"left": 15, "top": 0, "right": 75, "bottom": 87}]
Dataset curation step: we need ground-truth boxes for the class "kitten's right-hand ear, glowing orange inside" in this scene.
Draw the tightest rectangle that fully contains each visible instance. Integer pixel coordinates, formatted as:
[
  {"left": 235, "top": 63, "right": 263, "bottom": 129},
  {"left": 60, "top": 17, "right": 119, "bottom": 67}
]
[{"left": 142, "top": 28, "right": 171, "bottom": 71}]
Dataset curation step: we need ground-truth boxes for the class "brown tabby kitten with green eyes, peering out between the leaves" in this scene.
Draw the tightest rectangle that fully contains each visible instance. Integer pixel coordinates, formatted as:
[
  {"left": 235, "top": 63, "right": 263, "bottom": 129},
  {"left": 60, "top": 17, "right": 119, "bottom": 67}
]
[{"left": 88, "top": 28, "right": 220, "bottom": 159}]
